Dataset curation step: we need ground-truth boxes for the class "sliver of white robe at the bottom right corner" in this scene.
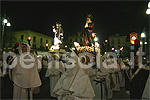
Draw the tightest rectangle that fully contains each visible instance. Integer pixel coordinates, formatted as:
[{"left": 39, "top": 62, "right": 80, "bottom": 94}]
[{"left": 142, "top": 75, "right": 150, "bottom": 100}]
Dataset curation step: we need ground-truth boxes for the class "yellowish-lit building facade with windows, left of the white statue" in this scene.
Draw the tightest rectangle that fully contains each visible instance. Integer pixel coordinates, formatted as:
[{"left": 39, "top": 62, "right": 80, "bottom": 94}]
[{"left": 6, "top": 30, "right": 53, "bottom": 50}]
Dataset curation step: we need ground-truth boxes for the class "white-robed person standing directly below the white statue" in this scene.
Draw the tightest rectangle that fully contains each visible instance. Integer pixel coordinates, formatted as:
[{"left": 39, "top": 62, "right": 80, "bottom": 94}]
[{"left": 45, "top": 54, "right": 65, "bottom": 97}]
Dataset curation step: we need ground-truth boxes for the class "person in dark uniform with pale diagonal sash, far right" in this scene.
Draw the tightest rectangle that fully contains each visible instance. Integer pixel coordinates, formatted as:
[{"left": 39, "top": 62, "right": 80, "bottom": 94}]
[{"left": 129, "top": 56, "right": 149, "bottom": 100}]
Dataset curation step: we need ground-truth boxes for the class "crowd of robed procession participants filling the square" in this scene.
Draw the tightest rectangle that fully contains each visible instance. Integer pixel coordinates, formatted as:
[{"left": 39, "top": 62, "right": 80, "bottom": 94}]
[{"left": 0, "top": 43, "right": 150, "bottom": 100}]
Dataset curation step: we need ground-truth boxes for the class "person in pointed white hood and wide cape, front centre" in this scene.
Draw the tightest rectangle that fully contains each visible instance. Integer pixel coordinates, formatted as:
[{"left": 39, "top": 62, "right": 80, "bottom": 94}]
[{"left": 53, "top": 51, "right": 95, "bottom": 100}]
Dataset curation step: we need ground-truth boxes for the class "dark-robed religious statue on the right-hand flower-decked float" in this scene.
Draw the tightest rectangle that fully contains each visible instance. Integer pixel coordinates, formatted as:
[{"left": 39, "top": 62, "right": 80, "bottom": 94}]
[{"left": 82, "top": 14, "right": 94, "bottom": 46}]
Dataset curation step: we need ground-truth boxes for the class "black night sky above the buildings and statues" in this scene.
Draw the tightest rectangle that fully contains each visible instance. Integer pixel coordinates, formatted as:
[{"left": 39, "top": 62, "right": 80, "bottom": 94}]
[{"left": 1, "top": 1, "right": 149, "bottom": 41}]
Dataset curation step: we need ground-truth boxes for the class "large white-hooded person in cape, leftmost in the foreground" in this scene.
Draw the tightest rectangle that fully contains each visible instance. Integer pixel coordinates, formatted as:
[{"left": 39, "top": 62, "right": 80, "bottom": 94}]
[{"left": 9, "top": 43, "right": 42, "bottom": 100}]
